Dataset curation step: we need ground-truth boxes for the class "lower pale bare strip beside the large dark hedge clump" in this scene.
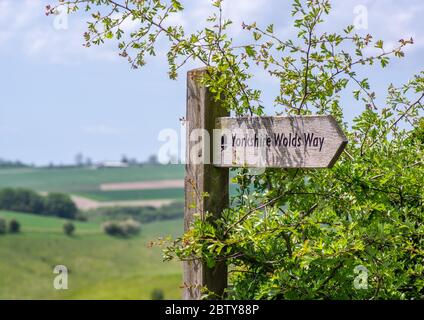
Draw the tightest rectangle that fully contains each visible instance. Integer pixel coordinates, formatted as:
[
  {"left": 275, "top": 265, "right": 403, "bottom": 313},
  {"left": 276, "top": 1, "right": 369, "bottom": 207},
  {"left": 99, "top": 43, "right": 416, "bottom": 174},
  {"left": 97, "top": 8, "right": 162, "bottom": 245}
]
[{"left": 71, "top": 195, "right": 175, "bottom": 210}]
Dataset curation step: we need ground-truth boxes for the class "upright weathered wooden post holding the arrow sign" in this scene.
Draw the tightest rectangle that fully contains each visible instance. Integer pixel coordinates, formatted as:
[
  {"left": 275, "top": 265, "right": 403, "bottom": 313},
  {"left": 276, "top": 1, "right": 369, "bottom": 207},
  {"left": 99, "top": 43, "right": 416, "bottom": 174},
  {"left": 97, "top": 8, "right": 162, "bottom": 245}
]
[{"left": 183, "top": 69, "right": 229, "bottom": 300}]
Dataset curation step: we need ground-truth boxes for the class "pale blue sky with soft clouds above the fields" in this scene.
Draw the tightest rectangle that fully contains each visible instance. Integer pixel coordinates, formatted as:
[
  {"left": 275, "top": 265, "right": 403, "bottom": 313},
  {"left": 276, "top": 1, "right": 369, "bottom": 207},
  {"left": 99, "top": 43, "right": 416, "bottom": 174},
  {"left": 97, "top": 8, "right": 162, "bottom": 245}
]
[{"left": 0, "top": 0, "right": 424, "bottom": 164}]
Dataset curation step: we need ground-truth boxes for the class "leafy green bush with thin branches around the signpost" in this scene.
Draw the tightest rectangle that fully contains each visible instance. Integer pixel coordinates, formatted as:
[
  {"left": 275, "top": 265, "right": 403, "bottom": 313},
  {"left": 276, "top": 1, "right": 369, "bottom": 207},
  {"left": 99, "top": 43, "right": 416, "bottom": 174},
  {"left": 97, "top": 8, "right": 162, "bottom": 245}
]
[{"left": 47, "top": 0, "right": 424, "bottom": 299}]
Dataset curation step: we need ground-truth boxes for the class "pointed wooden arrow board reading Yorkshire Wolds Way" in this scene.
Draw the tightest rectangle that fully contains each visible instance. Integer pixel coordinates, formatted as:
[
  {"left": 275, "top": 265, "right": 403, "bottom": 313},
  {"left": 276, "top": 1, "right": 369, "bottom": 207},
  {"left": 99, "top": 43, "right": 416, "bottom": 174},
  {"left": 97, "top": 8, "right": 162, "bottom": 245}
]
[{"left": 213, "top": 116, "right": 347, "bottom": 168}]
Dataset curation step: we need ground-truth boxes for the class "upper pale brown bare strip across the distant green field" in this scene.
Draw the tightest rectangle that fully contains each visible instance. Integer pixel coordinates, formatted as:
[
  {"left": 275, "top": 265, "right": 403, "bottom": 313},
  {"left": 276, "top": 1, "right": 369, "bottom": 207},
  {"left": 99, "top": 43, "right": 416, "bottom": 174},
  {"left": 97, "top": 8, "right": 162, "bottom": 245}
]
[{"left": 100, "top": 179, "right": 184, "bottom": 191}]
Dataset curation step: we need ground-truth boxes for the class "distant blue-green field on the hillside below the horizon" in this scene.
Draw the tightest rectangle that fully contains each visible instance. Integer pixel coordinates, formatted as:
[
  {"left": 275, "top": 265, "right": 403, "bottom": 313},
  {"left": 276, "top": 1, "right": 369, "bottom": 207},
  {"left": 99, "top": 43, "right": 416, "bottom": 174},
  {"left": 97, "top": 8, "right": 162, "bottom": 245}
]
[{"left": 0, "top": 165, "right": 184, "bottom": 201}]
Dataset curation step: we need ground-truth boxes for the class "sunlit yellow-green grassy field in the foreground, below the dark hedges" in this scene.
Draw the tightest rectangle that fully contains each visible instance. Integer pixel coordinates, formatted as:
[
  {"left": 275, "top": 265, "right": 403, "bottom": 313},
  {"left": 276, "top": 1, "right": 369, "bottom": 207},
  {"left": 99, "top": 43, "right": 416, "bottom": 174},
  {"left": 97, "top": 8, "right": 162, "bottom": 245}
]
[{"left": 0, "top": 211, "right": 183, "bottom": 299}]
